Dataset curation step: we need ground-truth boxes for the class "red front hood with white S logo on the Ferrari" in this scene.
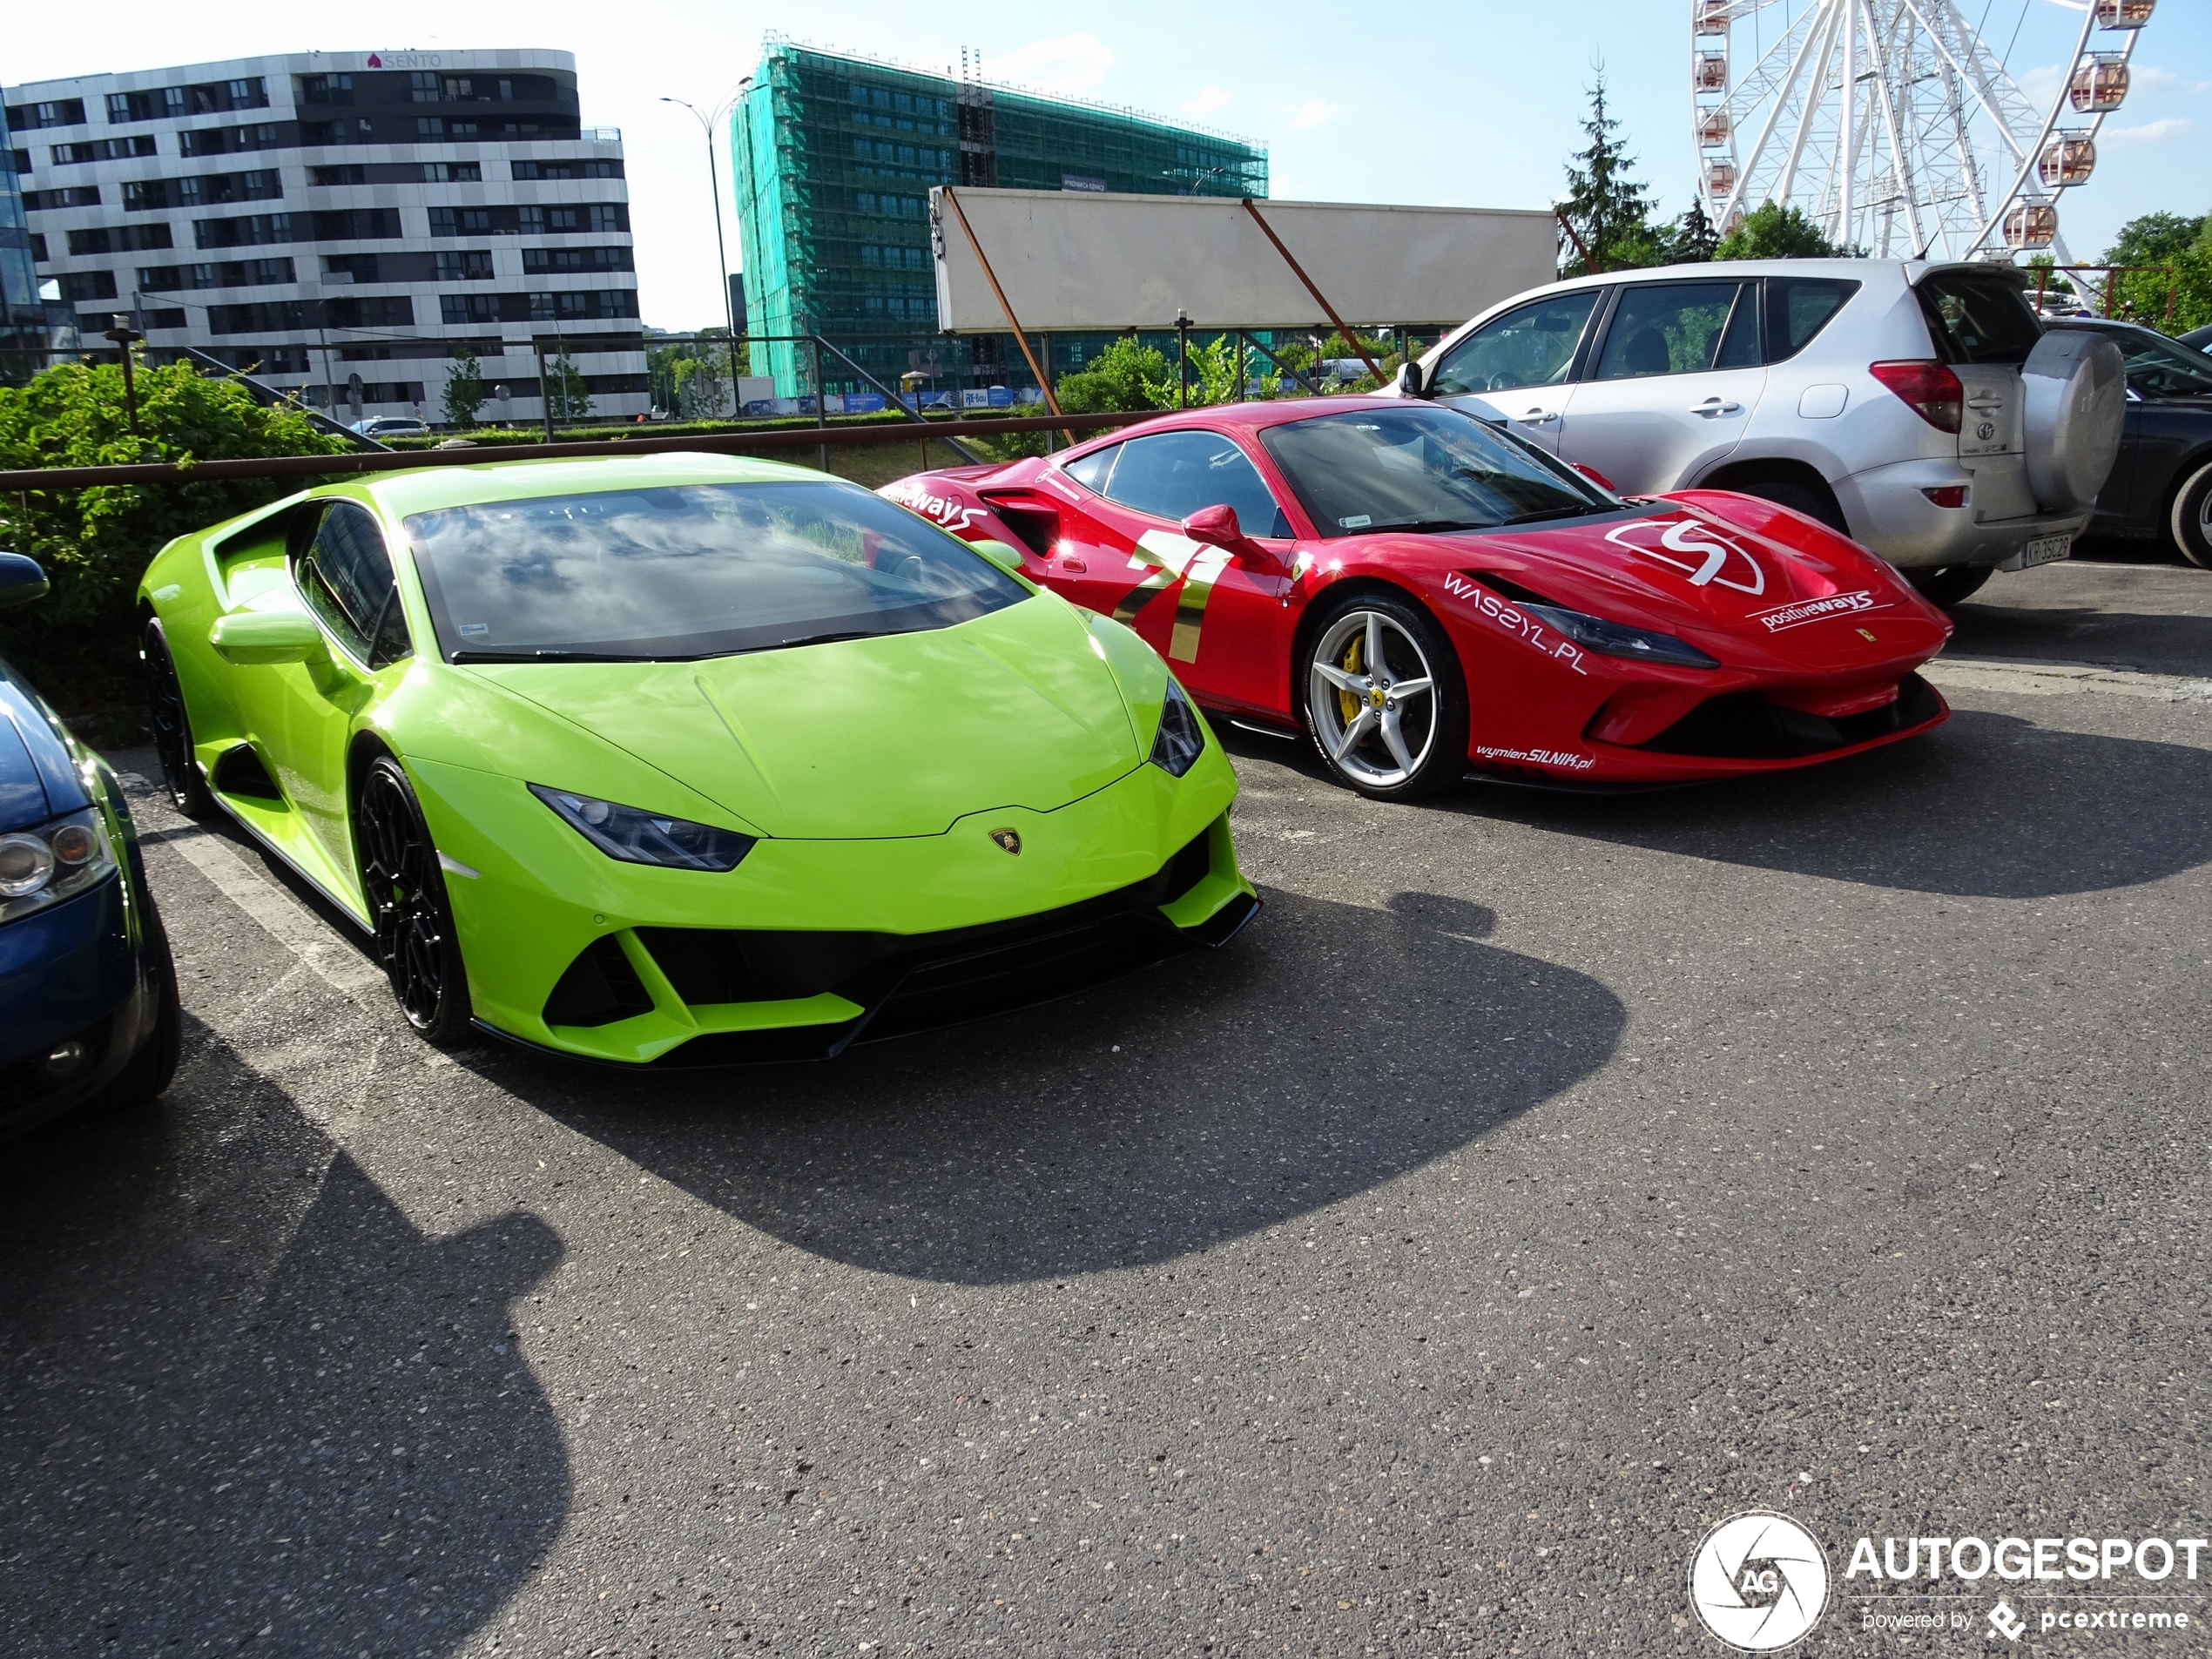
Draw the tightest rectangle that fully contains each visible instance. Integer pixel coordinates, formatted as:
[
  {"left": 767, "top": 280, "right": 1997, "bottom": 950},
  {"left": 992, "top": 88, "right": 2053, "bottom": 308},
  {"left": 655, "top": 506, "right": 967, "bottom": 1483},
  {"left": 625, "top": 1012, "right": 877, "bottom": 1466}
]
[{"left": 1471, "top": 502, "right": 1946, "bottom": 637}]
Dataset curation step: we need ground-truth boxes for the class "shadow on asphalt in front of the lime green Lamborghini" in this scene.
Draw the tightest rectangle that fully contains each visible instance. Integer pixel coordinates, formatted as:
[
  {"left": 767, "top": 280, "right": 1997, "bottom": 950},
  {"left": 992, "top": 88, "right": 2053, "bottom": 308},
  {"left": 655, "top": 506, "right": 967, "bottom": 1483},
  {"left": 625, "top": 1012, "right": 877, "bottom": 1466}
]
[{"left": 484, "top": 892, "right": 1626, "bottom": 1285}]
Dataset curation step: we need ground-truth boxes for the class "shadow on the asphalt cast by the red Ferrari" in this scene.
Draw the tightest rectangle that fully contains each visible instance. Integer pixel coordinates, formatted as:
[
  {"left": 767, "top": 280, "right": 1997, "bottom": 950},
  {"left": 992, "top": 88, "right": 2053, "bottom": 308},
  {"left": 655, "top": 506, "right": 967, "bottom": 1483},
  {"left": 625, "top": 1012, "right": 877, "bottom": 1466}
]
[{"left": 1438, "top": 708, "right": 2212, "bottom": 898}]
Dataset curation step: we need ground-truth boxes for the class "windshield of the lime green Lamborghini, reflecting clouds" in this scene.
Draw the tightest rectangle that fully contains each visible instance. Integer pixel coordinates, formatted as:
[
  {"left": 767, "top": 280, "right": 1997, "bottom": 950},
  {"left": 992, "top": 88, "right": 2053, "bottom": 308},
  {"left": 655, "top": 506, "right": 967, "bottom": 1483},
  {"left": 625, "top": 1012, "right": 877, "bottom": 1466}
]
[{"left": 407, "top": 480, "right": 1028, "bottom": 661}]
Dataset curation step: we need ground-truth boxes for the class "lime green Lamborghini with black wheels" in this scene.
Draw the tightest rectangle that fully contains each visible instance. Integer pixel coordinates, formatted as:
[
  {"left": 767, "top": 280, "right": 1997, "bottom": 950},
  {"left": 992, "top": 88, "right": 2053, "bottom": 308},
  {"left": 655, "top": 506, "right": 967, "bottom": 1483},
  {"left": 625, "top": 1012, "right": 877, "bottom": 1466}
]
[{"left": 139, "top": 455, "right": 1258, "bottom": 1066}]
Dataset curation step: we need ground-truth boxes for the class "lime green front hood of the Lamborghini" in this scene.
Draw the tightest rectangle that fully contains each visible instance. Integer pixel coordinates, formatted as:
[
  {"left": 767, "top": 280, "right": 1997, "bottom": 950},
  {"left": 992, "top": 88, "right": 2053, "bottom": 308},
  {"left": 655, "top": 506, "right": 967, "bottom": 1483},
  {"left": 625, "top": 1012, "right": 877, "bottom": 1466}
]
[{"left": 453, "top": 597, "right": 1143, "bottom": 840}]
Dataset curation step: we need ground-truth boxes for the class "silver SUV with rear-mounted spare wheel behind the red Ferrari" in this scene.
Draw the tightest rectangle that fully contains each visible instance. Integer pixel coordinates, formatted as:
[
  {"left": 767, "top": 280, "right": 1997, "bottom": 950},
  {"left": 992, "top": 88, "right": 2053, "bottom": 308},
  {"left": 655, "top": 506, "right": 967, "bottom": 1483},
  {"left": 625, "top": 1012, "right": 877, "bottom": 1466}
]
[{"left": 1398, "top": 259, "right": 2123, "bottom": 604}]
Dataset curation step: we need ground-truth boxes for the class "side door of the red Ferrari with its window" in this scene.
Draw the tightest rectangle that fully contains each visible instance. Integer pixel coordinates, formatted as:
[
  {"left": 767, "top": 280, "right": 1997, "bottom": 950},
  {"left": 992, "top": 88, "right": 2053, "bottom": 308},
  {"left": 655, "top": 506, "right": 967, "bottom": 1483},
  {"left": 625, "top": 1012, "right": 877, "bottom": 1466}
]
[{"left": 1046, "top": 427, "right": 1296, "bottom": 714}]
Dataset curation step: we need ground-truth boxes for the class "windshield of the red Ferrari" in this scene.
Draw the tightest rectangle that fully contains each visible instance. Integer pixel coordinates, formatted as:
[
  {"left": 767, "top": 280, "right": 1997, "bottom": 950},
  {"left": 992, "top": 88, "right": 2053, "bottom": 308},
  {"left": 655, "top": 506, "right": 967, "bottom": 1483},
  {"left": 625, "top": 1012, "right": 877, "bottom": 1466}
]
[{"left": 1258, "top": 401, "right": 1619, "bottom": 536}]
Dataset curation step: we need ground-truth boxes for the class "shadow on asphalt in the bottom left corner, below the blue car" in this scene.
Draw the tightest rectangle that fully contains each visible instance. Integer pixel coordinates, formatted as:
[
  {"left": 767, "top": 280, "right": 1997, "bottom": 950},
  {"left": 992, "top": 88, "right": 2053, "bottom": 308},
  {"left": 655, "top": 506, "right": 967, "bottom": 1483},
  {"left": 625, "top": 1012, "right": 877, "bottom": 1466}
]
[{"left": 0, "top": 1022, "right": 569, "bottom": 1655}]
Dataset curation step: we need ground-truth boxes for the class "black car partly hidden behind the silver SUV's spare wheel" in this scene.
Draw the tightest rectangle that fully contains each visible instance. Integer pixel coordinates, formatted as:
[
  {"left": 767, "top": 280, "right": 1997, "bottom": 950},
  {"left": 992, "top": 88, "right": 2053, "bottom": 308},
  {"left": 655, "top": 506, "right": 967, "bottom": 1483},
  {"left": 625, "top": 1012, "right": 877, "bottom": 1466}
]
[{"left": 2053, "top": 316, "right": 2212, "bottom": 570}]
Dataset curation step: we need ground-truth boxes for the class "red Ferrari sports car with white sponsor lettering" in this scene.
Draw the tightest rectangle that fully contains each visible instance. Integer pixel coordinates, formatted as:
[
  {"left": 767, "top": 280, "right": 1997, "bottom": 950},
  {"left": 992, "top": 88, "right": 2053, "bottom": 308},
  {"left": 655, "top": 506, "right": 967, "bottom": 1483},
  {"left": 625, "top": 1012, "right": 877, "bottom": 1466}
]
[{"left": 882, "top": 396, "right": 1951, "bottom": 799}]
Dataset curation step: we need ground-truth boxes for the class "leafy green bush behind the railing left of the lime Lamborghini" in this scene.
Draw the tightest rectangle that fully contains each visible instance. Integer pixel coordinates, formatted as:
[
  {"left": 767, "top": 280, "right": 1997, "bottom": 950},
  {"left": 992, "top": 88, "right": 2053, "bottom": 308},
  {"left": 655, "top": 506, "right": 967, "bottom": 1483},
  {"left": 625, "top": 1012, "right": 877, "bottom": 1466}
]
[{"left": 0, "top": 363, "right": 349, "bottom": 708}]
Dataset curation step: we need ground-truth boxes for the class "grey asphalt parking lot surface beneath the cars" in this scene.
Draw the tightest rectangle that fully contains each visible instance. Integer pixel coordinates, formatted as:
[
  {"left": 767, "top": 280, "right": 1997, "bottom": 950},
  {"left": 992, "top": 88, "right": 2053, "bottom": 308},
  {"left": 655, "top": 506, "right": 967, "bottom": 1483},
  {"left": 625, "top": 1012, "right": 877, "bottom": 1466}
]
[{"left": 0, "top": 548, "right": 2212, "bottom": 1659}]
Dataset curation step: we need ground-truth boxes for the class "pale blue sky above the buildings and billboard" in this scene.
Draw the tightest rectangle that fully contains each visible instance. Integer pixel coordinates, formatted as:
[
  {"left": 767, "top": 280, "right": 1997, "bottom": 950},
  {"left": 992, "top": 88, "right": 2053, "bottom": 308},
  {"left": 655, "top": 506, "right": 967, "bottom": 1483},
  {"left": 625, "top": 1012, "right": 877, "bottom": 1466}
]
[{"left": 0, "top": 0, "right": 2212, "bottom": 327}]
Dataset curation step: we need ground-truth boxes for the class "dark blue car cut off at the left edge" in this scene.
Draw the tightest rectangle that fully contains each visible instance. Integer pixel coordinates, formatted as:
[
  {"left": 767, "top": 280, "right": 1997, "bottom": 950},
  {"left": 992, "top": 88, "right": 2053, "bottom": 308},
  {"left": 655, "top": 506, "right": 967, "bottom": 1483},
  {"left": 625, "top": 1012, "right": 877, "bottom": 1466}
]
[{"left": 0, "top": 553, "right": 184, "bottom": 1137}]
